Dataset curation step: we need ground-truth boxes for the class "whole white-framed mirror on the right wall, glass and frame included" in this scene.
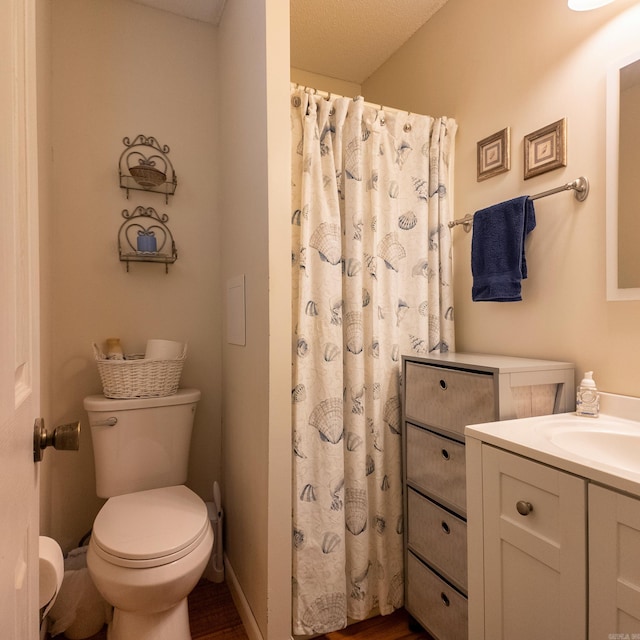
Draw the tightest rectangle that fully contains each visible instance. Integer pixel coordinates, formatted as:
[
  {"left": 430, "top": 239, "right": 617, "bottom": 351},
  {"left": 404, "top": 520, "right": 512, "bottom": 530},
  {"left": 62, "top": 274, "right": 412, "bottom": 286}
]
[{"left": 607, "top": 54, "right": 640, "bottom": 300}]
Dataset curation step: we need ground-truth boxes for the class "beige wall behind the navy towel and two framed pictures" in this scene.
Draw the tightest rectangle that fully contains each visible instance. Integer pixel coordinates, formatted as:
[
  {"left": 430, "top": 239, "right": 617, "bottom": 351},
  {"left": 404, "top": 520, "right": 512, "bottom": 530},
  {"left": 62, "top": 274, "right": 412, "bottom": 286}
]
[{"left": 363, "top": 0, "right": 640, "bottom": 396}]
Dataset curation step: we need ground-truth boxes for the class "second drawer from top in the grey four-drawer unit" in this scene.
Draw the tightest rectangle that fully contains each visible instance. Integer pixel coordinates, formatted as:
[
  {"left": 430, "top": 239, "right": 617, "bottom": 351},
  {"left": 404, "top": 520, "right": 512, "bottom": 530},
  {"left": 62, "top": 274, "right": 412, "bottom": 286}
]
[{"left": 406, "top": 423, "right": 467, "bottom": 514}]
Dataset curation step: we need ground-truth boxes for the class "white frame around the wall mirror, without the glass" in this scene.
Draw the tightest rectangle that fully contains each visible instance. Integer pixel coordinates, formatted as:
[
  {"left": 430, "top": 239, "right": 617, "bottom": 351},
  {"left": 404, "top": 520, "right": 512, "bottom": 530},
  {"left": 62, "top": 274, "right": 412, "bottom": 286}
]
[{"left": 606, "top": 52, "right": 640, "bottom": 300}]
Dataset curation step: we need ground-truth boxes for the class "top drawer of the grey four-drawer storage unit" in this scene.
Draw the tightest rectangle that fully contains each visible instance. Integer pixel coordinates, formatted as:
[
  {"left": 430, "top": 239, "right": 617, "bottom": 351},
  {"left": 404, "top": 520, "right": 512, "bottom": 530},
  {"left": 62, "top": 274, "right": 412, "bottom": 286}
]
[{"left": 405, "top": 362, "right": 497, "bottom": 435}]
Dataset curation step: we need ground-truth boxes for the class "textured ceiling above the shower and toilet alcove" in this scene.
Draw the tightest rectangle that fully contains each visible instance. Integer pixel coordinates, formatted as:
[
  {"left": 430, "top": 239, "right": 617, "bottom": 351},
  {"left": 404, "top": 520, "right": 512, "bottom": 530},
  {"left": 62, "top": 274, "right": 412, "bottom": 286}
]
[{"left": 133, "top": 0, "right": 447, "bottom": 84}]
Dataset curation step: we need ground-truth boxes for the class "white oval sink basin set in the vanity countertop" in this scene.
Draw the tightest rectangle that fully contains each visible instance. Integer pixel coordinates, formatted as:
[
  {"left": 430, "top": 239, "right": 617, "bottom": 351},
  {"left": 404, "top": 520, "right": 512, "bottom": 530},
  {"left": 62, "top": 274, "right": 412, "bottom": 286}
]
[{"left": 544, "top": 418, "right": 640, "bottom": 473}]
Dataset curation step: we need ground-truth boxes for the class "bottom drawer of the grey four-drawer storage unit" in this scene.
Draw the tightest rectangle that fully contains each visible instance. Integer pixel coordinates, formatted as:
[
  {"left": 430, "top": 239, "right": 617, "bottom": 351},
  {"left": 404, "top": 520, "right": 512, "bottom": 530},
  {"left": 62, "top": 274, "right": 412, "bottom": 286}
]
[{"left": 406, "top": 553, "right": 469, "bottom": 640}]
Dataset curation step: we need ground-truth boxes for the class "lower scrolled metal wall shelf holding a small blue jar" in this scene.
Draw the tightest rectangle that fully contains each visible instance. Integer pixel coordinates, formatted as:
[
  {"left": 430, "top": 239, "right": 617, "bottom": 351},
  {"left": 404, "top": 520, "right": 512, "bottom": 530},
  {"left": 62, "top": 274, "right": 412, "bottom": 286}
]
[{"left": 118, "top": 207, "right": 178, "bottom": 273}]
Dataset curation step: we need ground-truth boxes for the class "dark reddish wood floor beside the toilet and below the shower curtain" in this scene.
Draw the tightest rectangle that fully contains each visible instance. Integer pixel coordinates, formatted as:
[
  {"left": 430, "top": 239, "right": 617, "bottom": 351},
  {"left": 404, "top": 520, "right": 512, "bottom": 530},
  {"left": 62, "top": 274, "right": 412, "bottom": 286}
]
[{"left": 47, "top": 580, "right": 432, "bottom": 640}]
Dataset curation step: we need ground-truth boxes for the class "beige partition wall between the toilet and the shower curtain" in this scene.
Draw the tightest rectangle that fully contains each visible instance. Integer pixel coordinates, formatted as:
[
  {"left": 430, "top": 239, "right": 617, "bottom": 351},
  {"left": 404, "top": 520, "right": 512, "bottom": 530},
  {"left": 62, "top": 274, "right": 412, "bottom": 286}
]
[{"left": 220, "top": 0, "right": 291, "bottom": 640}]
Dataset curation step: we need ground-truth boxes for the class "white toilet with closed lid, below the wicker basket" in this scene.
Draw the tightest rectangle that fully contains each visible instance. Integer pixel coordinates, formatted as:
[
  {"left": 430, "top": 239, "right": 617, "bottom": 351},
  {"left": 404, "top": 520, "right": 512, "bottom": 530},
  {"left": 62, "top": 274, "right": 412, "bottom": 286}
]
[{"left": 84, "top": 389, "right": 213, "bottom": 640}]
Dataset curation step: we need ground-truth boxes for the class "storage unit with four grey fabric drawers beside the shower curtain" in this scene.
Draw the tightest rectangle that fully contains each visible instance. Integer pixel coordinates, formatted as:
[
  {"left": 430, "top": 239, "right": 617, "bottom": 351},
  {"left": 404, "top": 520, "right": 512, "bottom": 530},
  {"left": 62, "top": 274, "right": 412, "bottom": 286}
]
[{"left": 402, "top": 353, "right": 575, "bottom": 640}]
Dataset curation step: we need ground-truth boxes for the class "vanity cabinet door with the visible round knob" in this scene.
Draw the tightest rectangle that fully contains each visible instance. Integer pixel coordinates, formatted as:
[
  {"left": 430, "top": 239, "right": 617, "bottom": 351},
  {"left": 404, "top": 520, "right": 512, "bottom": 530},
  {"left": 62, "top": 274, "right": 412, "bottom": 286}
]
[{"left": 482, "top": 445, "right": 587, "bottom": 640}]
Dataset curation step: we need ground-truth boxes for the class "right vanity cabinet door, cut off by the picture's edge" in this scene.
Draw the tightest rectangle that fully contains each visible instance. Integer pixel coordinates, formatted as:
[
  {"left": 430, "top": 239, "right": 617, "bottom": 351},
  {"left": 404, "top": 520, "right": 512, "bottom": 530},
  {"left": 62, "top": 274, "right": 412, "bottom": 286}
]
[{"left": 589, "top": 485, "right": 640, "bottom": 639}]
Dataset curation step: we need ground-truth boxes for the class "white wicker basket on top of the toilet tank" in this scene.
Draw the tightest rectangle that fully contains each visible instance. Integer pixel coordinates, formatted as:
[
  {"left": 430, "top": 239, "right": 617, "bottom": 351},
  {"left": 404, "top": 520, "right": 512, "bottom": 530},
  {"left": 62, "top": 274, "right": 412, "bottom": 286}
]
[{"left": 93, "top": 344, "right": 187, "bottom": 398}]
